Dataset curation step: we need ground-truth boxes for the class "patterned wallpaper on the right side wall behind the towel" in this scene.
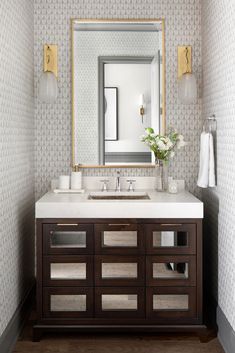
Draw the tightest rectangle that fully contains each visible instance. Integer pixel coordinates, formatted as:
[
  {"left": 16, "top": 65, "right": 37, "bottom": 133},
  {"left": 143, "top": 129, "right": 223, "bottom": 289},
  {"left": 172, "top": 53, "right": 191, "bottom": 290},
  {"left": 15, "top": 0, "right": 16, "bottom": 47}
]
[{"left": 202, "top": 0, "right": 235, "bottom": 329}]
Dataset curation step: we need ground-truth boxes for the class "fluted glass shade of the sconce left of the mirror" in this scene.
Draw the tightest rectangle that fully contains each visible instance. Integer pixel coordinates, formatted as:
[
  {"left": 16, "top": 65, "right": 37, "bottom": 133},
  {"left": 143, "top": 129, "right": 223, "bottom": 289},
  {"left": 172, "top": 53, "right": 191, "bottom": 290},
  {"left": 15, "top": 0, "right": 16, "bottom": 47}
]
[{"left": 39, "top": 72, "right": 58, "bottom": 103}]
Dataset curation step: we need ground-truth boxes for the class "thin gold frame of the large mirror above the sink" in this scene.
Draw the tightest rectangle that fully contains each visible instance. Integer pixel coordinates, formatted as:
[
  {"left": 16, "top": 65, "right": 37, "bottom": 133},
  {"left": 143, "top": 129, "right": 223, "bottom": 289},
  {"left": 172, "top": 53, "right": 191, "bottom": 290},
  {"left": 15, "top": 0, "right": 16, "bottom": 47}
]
[{"left": 70, "top": 18, "right": 166, "bottom": 169}]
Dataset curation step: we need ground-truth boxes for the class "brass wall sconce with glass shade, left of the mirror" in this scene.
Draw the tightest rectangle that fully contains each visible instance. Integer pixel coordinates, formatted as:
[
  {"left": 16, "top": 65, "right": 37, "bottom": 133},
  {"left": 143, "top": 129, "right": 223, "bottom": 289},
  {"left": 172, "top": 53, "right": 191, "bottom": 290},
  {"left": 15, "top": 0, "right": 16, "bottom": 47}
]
[{"left": 39, "top": 44, "right": 58, "bottom": 103}]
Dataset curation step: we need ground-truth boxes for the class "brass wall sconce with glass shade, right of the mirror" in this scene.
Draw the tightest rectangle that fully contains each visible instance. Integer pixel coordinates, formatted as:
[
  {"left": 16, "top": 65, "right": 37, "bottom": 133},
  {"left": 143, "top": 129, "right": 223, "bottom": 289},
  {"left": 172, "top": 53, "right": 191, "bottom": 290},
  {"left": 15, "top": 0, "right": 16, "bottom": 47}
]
[{"left": 178, "top": 46, "right": 197, "bottom": 104}]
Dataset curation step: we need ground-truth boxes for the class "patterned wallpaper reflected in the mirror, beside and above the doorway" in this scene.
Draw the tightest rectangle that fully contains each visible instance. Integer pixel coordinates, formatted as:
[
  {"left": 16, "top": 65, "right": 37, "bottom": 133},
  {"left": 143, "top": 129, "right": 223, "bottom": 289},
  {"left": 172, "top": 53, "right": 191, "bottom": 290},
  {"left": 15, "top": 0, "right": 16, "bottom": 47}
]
[{"left": 74, "top": 31, "right": 162, "bottom": 165}]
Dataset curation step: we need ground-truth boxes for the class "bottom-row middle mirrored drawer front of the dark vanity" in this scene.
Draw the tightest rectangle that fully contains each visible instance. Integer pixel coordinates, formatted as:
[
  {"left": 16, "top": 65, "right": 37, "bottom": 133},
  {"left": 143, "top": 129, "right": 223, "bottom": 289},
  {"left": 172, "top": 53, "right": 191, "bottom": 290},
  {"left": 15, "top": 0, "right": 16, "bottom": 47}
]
[{"left": 95, "top": 287, "right": 145, "bottom": 317}]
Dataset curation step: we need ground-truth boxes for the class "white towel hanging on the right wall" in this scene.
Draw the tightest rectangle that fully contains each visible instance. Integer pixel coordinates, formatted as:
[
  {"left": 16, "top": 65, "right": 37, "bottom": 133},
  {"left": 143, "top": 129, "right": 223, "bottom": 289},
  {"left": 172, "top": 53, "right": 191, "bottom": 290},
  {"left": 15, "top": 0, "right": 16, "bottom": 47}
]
[{"left": 197, "top": 132, "right": 215, "bottom": 188}]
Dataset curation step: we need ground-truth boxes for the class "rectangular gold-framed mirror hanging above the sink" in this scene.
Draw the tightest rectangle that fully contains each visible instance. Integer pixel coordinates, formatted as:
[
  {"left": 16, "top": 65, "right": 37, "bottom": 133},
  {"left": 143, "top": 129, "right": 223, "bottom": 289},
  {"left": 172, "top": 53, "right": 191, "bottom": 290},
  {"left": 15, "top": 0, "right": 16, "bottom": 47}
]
[{"left": 71, "top": 20, "right": 165, "bottom": 167}]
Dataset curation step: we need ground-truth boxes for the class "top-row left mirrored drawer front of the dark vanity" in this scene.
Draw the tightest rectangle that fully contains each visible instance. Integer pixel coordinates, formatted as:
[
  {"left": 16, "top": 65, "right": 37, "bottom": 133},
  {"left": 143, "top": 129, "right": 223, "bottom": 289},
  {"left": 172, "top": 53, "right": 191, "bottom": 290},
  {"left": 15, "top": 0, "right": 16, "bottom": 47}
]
[{"left": 43, "top": 224, "right": 93, "bottom": 254}]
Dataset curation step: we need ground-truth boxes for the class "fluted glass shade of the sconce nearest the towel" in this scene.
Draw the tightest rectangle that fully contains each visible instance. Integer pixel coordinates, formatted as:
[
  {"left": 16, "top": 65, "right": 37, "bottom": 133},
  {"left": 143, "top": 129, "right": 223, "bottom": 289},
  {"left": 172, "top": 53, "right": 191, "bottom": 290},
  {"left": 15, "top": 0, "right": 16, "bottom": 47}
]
[{"left": 178, "top": 72, "right": 197, "bottom": 104}]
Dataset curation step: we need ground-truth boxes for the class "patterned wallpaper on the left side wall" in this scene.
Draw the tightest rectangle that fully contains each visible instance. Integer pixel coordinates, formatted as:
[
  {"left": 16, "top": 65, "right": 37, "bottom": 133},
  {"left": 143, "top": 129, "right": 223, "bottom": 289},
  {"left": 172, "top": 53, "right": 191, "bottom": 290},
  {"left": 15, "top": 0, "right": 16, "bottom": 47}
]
[{"left": 0, "top": 0, "right": 34, "bottom": 336}]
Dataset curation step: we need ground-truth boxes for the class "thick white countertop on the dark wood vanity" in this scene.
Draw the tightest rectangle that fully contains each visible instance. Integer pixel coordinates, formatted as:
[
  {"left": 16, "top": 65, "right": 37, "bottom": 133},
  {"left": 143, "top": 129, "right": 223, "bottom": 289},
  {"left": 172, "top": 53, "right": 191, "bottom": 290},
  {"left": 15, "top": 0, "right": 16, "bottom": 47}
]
[{"left": 36, "top": 190, "right": 203, "bottom": 218}]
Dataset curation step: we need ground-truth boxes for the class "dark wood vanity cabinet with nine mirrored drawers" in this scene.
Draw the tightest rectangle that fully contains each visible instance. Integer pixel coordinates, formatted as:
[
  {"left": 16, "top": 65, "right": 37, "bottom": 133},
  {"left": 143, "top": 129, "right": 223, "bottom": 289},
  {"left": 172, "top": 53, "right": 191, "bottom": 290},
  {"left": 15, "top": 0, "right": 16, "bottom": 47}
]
[{"left": 34, "top": 219, "right": 204, "bottom": 340}]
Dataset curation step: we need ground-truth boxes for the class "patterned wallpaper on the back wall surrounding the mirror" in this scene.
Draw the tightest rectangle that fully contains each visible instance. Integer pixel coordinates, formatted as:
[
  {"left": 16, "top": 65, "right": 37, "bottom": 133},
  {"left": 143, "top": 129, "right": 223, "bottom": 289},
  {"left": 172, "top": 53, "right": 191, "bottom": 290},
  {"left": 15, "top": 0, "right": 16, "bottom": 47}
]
[{"left": 34, "top": 0, "right": 201, "bottom": 198}]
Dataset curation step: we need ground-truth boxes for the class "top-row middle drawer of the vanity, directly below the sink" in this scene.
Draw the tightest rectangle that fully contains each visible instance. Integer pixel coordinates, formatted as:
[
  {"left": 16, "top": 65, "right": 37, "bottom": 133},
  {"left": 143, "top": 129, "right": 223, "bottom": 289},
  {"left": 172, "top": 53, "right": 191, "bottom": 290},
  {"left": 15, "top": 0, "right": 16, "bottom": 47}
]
[{"left": 95, "top": 222, "right": 145, "bottom": 255}]
